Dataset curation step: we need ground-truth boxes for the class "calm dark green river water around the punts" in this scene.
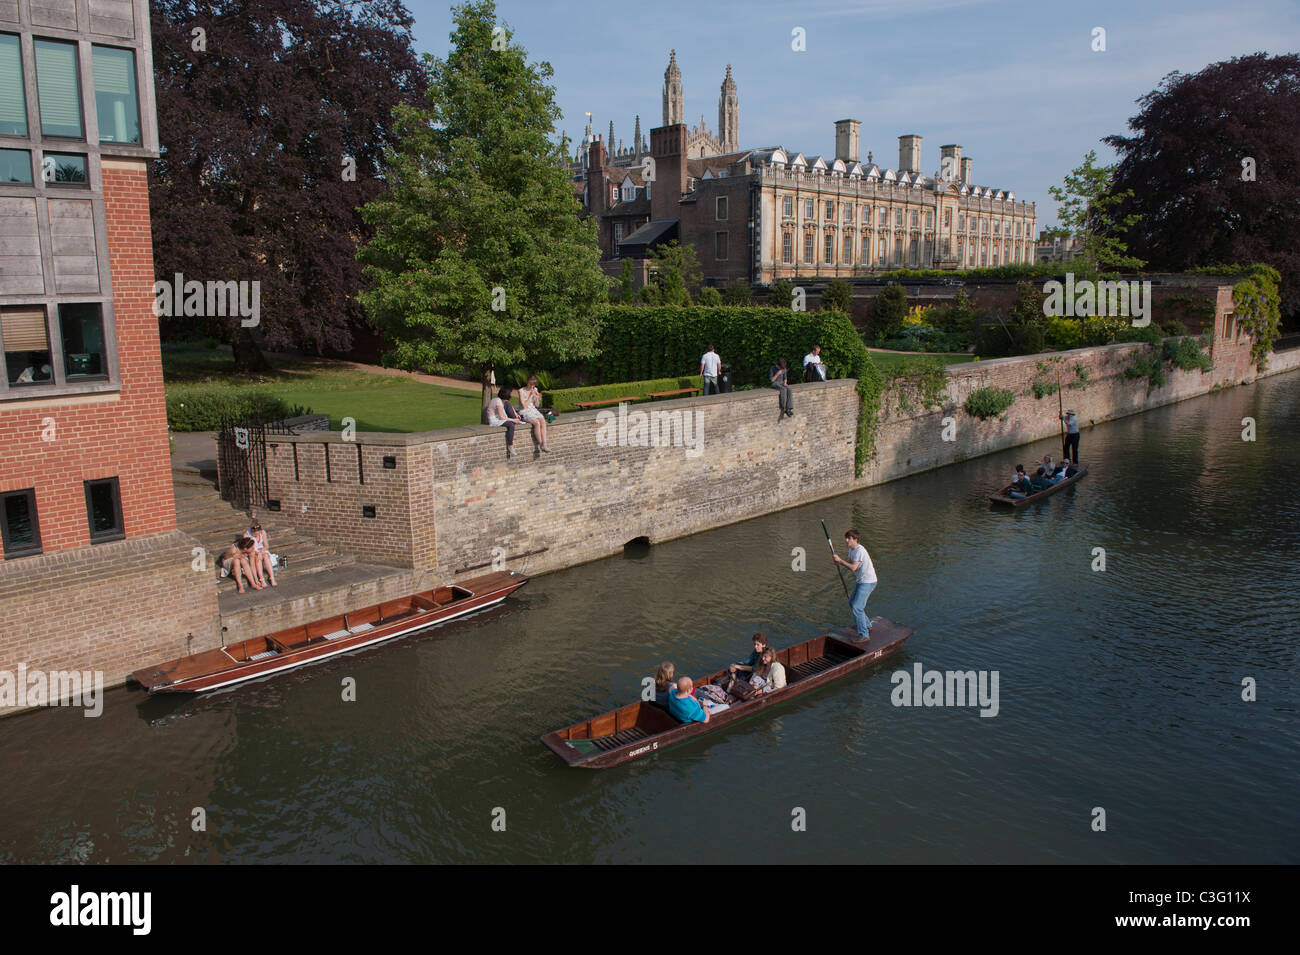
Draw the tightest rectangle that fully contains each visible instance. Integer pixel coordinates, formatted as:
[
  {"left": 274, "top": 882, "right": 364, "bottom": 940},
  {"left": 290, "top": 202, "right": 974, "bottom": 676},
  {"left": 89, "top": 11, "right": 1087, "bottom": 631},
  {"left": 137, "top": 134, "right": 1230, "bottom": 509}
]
[{"left": 0, "top": 374, "right": 1300, "bottom": 863}]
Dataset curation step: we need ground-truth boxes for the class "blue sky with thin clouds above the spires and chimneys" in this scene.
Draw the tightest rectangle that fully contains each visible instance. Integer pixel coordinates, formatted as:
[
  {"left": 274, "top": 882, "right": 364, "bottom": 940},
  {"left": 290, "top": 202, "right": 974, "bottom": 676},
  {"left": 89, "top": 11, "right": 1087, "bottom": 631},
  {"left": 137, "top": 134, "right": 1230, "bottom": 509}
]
[{"left": 406, "top": 0, "right": 1300, "bottom": 227}]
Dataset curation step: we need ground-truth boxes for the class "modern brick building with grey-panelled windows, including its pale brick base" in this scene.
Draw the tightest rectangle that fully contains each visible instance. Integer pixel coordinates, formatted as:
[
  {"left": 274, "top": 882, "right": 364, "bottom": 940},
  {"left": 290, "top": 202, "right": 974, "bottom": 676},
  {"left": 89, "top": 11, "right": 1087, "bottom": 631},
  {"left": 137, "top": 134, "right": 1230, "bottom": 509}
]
[{"left": 0, "top": 0, "right": 216, "bottom": 712}]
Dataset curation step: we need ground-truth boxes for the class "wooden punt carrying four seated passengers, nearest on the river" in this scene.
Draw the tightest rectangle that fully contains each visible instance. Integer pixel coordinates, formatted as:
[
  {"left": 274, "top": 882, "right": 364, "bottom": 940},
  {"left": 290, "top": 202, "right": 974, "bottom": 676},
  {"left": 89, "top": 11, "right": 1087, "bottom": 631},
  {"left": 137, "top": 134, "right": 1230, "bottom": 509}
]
[{"left": 542, "top": 617, "right": 913, "bottom": 769}]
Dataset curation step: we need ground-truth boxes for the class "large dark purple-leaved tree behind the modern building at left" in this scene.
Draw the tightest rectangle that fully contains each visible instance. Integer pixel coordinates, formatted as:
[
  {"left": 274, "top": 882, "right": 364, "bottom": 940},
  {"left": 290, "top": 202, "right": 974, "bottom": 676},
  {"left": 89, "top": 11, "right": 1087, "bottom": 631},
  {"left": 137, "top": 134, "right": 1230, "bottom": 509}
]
[{"left": 150, "top": 0, "right": 424, "bottom": 369}]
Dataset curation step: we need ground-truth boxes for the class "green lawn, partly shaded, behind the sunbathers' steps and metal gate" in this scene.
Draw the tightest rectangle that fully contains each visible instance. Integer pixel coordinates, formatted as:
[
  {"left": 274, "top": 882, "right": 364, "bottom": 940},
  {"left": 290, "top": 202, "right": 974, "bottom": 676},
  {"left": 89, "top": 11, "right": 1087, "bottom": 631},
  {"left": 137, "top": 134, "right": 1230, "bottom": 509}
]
[{"left": 163, "top": 346, "right": 481, "bottom": 431}]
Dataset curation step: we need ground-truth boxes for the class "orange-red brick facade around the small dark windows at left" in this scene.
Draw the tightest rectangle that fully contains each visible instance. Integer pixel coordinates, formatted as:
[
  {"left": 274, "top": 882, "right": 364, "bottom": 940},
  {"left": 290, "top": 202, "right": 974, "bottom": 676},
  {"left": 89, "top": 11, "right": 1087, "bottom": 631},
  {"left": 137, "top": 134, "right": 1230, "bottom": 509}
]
[{"left": 0, "top": 160, "right": 176, "bottom": 556}]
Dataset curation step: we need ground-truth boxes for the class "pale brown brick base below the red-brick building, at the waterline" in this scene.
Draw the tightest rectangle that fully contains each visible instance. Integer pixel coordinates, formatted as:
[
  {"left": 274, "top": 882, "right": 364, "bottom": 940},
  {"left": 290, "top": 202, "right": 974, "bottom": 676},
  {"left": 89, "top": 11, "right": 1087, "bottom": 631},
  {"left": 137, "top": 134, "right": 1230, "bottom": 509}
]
[{"left": 0, "top": 530, "right": 221, "bottom": 715}]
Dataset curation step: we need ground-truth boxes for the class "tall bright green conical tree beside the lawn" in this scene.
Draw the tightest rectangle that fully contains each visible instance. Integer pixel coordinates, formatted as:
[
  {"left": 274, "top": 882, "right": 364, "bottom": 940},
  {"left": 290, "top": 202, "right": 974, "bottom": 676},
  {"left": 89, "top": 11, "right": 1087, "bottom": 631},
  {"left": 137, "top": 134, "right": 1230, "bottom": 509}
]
[{"left": 360, "top": 0, "right": 607, "bottom": 416}]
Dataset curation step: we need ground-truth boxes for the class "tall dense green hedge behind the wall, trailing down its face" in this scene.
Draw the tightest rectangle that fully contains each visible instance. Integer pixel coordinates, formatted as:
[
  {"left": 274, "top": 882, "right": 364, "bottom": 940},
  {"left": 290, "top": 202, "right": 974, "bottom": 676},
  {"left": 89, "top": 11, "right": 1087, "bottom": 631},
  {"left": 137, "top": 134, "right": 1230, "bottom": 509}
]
[{"left": 595, "top": 305, "right": 884, "bottom": 476}]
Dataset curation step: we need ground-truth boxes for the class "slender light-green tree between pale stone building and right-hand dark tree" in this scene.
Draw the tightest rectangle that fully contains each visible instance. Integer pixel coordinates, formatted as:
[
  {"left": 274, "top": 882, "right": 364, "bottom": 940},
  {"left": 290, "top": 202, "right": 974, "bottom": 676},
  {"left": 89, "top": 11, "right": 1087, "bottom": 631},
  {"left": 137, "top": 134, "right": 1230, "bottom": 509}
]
[{"left": 1047, "top": 149, "right": 1145, "bottom": 272}]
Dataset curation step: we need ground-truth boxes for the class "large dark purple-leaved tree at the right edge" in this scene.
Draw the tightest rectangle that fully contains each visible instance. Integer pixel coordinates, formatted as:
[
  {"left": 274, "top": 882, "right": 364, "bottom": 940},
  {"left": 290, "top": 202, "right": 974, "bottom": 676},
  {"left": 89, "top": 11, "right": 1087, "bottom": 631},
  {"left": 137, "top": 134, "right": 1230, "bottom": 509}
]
[{"left": 1104, "top": 53, "right": 1300, "bottom": 314}]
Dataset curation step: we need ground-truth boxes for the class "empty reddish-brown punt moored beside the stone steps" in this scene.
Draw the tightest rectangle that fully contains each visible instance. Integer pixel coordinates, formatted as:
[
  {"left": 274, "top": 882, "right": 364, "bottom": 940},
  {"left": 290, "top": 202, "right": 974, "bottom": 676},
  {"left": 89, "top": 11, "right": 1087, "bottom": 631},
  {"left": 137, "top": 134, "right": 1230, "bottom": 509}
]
[{"left": 130, "top": 570, "right": 528, "bottom": 694}]
